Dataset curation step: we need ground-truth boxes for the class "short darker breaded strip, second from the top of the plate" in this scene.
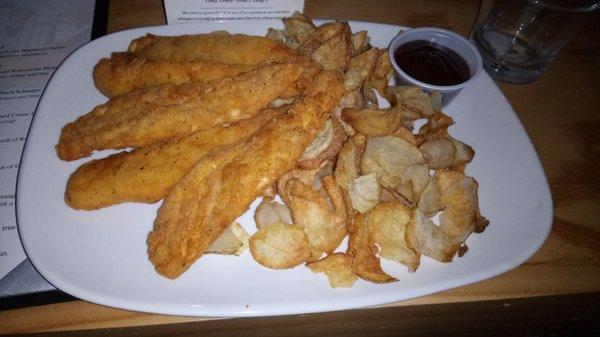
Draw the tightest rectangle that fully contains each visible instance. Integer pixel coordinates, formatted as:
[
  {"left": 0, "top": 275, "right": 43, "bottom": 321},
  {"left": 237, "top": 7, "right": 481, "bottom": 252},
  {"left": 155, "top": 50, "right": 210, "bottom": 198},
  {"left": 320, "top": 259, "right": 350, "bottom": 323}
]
[{"left": 93, "top": 52, "right": 256, "bottom": 97}]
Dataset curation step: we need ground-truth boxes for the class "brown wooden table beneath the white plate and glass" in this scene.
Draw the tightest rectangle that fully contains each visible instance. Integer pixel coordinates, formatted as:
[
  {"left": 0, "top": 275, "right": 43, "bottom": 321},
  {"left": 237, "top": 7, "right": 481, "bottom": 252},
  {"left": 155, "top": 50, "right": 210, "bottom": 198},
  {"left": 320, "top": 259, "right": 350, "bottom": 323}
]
[{"left": 0, "top": 0, "right": 600, "bottom": 336}]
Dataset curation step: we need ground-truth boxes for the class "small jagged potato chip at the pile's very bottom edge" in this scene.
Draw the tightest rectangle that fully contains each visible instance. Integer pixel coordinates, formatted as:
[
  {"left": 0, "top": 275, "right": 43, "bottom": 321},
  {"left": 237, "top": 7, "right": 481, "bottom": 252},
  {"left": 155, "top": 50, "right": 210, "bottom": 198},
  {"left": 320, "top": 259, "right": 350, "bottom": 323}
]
[{"left": 306, "top": 253, "right": 358, "bottom": 288}]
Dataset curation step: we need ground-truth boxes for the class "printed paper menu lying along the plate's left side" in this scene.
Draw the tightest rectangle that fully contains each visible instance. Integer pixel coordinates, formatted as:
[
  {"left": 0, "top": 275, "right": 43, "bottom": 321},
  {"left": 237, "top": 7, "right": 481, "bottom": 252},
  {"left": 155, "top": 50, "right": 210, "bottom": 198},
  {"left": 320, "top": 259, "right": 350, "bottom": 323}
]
[{"left": 0, "top": 0, "right": 95, "bottom": 279}]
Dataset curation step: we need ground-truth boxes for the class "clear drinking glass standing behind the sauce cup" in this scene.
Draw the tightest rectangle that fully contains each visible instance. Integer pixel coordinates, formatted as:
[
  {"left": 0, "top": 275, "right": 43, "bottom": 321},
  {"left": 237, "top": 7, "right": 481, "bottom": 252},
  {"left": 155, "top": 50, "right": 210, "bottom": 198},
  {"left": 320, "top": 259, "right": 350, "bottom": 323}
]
[{"left": 471, "top": 0, "right": 600, "bottom": 84}]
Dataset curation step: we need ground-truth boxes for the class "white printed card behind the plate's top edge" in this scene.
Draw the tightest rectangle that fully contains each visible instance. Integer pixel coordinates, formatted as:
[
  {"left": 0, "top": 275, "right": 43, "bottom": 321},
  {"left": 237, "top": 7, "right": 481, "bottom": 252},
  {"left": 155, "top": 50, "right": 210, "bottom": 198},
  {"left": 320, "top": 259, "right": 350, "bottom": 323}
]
[{"left": 164, "top": 0, "right": 304, "bottom": 25}]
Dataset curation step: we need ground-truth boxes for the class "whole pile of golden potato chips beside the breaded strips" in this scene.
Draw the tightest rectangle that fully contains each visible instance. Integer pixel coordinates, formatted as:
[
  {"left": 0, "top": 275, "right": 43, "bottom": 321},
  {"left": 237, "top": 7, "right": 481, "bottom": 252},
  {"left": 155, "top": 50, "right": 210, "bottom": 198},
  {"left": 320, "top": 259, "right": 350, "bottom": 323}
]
[{"left": 216, "top": 13, "right": 488, "bottom": 287}]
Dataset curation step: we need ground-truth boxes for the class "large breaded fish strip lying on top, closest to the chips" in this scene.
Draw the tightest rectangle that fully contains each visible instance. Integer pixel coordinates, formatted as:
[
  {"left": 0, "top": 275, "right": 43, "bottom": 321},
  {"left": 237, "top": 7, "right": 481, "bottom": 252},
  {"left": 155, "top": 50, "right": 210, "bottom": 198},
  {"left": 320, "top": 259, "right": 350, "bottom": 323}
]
[{"left": 147, "top": 72, "right": 343, "bottom": 278}]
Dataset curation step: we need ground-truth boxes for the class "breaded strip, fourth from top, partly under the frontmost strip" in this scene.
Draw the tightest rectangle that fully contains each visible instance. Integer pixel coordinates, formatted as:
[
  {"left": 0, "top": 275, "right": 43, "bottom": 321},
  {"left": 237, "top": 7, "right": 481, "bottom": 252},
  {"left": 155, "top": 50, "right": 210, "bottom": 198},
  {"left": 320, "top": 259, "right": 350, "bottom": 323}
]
[{"left": 65, "top": 106, "right": 289, "bottom": 210}]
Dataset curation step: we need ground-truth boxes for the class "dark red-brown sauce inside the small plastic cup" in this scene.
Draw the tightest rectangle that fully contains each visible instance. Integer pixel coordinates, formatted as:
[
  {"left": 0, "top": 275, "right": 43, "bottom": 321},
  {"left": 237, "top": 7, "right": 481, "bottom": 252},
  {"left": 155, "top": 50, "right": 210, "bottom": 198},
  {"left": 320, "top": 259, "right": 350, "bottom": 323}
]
[{"left": 394, "top": 40, "right": 471, "bottom": 86}]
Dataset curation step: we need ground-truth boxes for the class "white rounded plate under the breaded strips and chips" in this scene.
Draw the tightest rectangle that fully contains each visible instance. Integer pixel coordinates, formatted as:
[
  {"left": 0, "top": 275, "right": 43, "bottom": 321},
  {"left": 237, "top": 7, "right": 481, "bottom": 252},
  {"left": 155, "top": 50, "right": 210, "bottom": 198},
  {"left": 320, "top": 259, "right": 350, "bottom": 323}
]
[{"left": 17, "top": 21, "right": 552, "bottom": 316}]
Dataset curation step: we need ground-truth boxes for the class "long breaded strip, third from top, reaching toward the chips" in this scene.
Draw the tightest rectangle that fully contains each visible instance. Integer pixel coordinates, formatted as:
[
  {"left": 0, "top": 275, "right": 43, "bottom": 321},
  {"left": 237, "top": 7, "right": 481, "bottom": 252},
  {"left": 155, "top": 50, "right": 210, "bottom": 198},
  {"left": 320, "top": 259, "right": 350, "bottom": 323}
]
[{"left": 56, "top": 63, "right": 318, "bottom": 160}]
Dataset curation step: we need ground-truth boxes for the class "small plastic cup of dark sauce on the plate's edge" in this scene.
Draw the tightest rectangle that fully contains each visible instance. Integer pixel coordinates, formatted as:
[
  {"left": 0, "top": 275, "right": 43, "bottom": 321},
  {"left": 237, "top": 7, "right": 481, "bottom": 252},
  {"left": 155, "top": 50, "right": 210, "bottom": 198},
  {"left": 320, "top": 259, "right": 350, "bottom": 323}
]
[{"left": 388, "top": 27, "right": 482, "bottom": 106}]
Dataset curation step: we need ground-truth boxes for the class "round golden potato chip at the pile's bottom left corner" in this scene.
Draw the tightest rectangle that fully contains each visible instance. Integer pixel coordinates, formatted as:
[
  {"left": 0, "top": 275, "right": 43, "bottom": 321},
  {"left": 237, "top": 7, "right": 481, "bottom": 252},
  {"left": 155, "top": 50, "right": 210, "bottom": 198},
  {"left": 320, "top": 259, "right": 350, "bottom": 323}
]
[{"left": 249, "top": 222, "right": 311, "bottom": 269}]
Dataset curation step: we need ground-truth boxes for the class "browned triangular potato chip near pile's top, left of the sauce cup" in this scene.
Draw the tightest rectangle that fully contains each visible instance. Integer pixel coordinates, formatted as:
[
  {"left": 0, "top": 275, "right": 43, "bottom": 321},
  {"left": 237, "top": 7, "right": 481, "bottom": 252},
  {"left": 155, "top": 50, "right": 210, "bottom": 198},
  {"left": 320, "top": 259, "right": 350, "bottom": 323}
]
[{"left": 310, "top": 30, "right": 352, "bottom": 70}]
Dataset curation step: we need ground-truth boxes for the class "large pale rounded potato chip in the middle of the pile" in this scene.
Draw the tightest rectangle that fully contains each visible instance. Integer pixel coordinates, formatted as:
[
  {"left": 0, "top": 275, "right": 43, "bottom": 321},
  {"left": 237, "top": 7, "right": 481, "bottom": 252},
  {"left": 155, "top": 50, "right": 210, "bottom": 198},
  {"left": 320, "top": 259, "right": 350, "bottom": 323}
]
[{"left": 360, "top": 136, "right": 429, "bottom": 197}]
